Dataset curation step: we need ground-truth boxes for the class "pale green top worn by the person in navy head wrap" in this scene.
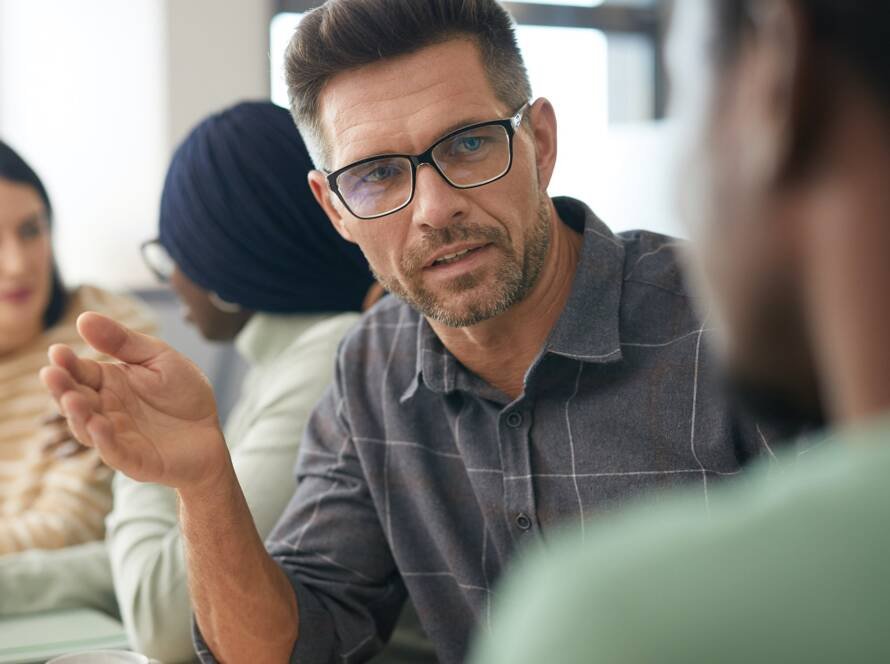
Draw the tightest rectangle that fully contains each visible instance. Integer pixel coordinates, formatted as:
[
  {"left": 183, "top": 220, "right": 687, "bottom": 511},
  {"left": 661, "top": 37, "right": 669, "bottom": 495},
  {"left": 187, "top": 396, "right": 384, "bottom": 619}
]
[{"left": 107, "top": 313, "right": 359, "bottom": 664}]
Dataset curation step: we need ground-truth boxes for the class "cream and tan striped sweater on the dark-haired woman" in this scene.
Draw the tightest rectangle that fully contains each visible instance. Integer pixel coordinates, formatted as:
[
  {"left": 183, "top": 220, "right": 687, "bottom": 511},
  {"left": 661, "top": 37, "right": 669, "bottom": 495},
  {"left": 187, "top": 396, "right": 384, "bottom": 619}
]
[{"left": 0, "top": 286, "right": 153, "bottom": 555}]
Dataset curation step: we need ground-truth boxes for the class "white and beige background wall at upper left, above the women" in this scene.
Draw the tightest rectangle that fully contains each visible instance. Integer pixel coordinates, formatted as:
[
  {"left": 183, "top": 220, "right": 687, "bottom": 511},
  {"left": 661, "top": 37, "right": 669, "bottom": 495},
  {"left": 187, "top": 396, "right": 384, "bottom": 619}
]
[{"left": 0, "top": 0, "right": 271, "bottom": 289}]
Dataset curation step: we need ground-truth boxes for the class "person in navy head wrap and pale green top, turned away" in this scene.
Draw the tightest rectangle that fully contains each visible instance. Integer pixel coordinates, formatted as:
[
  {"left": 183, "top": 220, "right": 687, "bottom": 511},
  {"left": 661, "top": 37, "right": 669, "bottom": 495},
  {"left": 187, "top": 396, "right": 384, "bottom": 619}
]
[{"left": 108, "top": 102, "right": 423, "bottom": 662}]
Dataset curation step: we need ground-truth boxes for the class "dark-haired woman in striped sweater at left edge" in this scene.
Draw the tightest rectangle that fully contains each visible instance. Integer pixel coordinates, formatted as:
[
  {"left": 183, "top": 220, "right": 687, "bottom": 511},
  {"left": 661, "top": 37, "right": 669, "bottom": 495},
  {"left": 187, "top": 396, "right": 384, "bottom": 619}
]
[{"left": 0, "top": 141, "right": 151, "bottom": 556}]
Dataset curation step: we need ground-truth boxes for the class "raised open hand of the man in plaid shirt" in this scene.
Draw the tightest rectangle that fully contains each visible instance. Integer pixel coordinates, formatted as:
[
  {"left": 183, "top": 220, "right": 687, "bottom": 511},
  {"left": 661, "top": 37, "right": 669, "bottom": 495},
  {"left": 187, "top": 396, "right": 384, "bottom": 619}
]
[{"left": 40, "top": 313, "right": 228, "bottom": 489}]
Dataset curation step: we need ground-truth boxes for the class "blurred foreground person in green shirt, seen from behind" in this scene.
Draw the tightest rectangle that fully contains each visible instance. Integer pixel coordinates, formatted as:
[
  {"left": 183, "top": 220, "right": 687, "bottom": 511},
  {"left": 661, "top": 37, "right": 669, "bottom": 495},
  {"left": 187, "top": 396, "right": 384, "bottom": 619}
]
[{"left": 473, "top": 0, "right": 890, "bottom": 664}]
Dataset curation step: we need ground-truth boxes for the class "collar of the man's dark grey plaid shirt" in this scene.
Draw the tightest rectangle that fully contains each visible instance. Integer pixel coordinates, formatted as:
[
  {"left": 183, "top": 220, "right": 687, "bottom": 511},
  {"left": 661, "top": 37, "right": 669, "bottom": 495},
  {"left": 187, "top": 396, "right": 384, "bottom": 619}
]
[{"left": 400, "top": 197, "right": 624, "bottom": 403}]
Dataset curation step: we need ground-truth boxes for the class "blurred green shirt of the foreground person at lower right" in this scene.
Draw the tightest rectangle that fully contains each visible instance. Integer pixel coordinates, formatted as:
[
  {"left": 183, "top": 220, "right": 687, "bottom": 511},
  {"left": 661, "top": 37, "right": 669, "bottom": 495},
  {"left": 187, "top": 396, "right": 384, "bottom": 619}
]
[{"left": 473, "top": 418, "right": 890, "bottom": 664}]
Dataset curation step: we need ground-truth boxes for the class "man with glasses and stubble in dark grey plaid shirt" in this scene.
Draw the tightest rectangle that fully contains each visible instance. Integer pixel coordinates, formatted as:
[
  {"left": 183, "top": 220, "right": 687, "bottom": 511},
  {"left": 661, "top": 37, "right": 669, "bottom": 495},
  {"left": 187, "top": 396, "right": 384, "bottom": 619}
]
[{"left": 45, "top": 0, "right": 763, "bottom": 662}]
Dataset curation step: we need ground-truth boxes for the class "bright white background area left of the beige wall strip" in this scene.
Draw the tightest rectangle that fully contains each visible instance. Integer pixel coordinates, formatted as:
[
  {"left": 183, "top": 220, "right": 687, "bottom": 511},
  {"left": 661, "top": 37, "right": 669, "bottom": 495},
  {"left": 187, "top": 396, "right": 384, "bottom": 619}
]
[{"left": 0, "top": 0, "right": 167, "bottom": 286}]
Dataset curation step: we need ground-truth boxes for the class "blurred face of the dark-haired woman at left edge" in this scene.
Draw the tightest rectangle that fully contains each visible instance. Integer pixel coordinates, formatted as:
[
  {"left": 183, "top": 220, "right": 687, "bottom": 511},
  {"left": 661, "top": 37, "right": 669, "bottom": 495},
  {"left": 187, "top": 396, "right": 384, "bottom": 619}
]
[{"left": 0, "top": 179, "right": 53, "bottom": 356}]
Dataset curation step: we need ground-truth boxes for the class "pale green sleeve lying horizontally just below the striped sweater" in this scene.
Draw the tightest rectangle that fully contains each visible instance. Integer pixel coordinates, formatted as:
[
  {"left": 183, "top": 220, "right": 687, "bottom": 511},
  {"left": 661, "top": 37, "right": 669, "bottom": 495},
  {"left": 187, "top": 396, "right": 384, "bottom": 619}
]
[{"left": 0, "top": 541, "right": 117, "bottom": 616}]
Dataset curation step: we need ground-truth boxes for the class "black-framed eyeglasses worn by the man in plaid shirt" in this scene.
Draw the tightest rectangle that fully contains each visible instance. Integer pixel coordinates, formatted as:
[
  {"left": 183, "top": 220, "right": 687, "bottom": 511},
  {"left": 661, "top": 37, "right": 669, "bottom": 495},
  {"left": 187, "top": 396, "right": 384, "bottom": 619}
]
[{"left": 327, "top": 102, "right": 529, "bottom": 219}]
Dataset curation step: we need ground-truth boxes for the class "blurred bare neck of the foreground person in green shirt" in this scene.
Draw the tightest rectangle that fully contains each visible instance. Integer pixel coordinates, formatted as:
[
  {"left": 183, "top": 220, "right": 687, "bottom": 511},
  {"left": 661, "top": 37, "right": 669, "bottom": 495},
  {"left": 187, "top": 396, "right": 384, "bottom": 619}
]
[{"left": 802, "top": 105, "right": 890, "bottom": 425}]
